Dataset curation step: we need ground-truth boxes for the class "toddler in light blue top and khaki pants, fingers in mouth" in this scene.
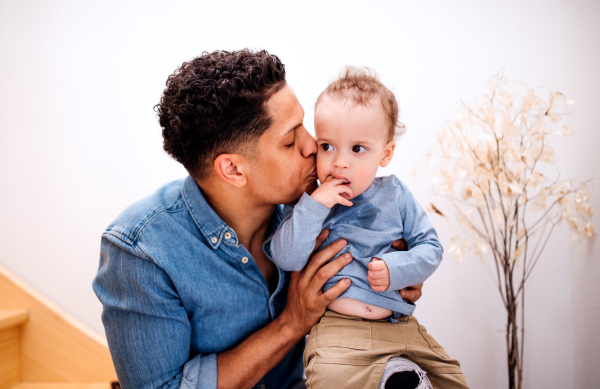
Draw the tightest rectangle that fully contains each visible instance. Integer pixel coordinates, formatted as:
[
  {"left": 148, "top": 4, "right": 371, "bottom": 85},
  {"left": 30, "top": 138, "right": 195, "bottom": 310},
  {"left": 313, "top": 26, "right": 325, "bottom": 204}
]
[{"left": 270, "top": 68, "right": 467, "bottom": 389}]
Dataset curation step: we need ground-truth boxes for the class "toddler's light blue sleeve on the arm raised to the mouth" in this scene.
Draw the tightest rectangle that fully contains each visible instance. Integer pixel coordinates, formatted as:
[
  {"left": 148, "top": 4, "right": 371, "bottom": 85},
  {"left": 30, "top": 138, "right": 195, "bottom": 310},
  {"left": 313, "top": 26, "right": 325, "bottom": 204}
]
[{"left": 270, "top": 193, "right": 329, "bottom": 271}]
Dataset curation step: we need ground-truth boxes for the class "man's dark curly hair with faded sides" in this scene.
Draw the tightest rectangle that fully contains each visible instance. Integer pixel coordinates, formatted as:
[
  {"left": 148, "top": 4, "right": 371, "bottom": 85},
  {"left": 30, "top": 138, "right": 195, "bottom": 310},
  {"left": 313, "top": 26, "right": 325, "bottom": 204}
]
[{"left": 155, "top": 49, "right": 286, "bottom": 180}]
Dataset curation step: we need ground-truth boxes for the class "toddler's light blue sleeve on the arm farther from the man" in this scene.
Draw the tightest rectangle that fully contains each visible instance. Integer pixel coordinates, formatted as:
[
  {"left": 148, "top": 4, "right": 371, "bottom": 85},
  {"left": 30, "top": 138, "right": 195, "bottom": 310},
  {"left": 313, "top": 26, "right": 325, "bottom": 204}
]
[{"left": 381, "top": 180, "right": 443, "bottom": 290}]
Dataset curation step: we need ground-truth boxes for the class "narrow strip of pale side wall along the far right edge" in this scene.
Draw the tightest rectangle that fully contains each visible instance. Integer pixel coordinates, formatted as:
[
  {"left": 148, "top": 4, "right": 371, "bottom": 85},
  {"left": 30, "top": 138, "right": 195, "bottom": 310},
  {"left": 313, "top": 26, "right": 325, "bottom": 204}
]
[{"left": 560, "top": 0, "right": 600, "bottom": 388}]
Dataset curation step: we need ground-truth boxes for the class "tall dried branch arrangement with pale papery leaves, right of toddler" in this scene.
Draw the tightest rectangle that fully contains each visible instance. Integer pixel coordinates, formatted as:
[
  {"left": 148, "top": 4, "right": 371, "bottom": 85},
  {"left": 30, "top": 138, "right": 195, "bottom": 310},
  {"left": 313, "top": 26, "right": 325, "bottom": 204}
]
[{"left": 414, "top": 72, "right": 595, "bottom": 388}]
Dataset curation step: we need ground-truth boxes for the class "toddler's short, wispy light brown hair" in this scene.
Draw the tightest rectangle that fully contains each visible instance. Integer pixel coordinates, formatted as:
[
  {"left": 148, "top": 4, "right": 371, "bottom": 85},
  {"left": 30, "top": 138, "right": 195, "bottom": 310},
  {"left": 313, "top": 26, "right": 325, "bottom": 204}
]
[{"left": 315, "top": 66, "right": 406, "bottom": 142}]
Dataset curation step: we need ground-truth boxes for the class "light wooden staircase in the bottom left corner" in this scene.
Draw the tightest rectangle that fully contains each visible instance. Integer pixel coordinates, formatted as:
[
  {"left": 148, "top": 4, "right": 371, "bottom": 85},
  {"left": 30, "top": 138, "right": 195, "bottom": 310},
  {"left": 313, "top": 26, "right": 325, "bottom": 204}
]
[{"left": 0, "top": 265, "right": 117, "bottom": 389}]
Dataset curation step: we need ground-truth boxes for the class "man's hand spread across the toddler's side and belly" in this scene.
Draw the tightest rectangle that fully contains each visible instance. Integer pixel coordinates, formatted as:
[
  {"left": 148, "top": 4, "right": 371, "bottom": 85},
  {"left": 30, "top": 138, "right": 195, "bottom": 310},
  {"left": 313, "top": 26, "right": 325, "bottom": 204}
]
[{"left": 279, "top": 230, "right": 352, "bottom": 336}]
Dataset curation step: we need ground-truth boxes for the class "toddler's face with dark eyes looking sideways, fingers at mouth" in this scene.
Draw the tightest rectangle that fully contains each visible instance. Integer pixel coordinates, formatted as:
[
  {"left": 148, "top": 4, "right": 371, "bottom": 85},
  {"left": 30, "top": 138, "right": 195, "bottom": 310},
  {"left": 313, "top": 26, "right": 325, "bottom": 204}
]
[{"left": 315, "top": 97, "right": 396, "bottom": 197}]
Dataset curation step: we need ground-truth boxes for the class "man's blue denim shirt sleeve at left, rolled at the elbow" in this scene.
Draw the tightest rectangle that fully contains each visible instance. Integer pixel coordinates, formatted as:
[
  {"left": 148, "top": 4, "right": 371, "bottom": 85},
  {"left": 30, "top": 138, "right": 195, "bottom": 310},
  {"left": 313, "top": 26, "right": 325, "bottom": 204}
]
[{"left": 93, "top": 232, "right": 217, "bottom": 389}]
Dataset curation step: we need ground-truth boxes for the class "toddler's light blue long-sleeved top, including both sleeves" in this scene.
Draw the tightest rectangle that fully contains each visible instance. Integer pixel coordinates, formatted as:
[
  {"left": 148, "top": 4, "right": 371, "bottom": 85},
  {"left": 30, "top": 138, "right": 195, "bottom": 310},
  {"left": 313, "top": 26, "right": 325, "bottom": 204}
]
[{"left": 270, "top": 175, "right": 443, "bottom": 315}]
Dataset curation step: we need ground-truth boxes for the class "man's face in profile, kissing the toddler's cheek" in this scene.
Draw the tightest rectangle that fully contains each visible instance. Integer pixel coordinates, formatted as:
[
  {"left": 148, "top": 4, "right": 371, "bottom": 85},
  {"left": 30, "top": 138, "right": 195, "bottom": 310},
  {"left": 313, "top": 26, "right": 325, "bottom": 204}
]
[{"left": 248, "top": 85, "right": 317, "bottom": 204}]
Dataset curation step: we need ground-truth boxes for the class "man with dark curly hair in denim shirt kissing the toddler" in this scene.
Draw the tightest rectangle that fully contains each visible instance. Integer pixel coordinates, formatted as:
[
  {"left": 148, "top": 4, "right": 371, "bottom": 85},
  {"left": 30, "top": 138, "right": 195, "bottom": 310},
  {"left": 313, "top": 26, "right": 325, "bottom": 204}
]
[{"left": 94, "top": 50, "right": 421, "bottom": 389}]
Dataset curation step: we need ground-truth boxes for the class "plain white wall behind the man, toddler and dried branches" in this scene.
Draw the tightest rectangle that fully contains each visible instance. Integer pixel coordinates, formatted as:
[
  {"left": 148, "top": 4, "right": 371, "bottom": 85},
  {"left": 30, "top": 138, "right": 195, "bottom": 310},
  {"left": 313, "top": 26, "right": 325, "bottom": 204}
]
[{"left": 0, "top": 0, "right": 600, "bottom": 388}]
